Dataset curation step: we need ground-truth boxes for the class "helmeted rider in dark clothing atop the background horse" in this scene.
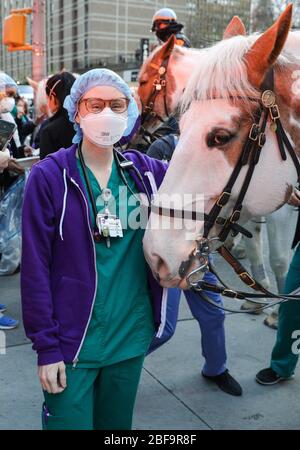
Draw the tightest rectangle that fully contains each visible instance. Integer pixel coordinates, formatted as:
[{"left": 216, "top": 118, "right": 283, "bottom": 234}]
[{"left": 151, "top": 8, "right": 191, "bottom": 48}]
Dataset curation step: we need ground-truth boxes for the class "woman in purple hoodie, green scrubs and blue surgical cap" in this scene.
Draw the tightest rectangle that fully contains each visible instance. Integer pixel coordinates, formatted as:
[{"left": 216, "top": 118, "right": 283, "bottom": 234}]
[{"left": 21, "top": 69, "right": 171, "bottom": 430}]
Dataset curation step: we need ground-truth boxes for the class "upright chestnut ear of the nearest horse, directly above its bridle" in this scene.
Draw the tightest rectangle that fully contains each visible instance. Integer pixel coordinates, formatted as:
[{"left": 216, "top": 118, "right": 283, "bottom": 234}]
[{"left": 245, "top": 3, "right": 293, "bottom": 88}]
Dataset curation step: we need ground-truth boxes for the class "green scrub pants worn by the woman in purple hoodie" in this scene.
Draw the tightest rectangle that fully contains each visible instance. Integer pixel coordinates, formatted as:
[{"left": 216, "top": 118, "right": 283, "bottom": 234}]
[{"left": 42, "top": 355, "right": 145, "bottom": 430}]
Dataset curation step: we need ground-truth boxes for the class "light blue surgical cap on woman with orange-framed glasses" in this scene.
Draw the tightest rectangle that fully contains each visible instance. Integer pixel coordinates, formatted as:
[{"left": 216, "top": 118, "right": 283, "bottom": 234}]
[{"left": 64, "top": 69, "right": 139, "bottom": 144}]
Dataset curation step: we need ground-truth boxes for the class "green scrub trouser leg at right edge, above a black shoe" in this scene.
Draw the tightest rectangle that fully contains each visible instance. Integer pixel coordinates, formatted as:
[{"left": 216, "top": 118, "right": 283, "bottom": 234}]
[{"left": 271, "top": 245, "right": 300, "bottom": 378}]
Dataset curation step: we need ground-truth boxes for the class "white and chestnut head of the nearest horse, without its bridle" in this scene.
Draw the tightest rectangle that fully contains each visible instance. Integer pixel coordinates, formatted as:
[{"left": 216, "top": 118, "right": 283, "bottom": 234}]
[{"left": 144, "top": 6, "right": 300, "bottom": 288}]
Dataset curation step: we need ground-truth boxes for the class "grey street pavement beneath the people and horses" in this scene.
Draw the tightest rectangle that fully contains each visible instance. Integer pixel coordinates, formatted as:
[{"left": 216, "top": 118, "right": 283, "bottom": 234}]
[{"left": 0, "top": 221, "right": 300, "bottom": 430}]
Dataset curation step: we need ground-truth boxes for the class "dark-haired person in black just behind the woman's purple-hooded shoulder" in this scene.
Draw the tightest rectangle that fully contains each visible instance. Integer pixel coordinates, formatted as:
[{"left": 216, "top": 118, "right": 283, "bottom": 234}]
[{"left": 40, "top": 72, "right": 76, "bottom": 160}]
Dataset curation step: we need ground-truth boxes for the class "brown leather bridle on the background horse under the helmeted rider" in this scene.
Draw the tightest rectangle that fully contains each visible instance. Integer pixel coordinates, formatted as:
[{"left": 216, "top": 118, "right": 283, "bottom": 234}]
[{"left": 139, "top": 52, "right": 171, "bottom": 143}]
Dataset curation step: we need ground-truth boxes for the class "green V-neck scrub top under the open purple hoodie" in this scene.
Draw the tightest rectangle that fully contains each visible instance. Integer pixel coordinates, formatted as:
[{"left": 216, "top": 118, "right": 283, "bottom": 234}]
[{"left": 77, "top": 155, "right": 155, "bottom": 368}]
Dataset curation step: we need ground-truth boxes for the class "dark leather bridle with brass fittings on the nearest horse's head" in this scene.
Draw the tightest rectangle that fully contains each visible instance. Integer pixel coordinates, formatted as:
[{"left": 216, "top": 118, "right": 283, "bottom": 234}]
[{"left": 151, "top": 68, "right": 300, "bottom": 313}]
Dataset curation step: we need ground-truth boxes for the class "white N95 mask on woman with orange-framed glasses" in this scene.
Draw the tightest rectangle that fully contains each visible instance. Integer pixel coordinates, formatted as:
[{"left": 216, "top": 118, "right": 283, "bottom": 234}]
[{"left": 80, "top": 108, "right": 128, "bottom": 147}]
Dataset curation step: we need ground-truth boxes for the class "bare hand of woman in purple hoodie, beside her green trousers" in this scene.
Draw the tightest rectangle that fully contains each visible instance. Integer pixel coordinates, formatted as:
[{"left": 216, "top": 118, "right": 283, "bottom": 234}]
[{"left": 38, "top": 361, "right": 67, "bottom": 394}]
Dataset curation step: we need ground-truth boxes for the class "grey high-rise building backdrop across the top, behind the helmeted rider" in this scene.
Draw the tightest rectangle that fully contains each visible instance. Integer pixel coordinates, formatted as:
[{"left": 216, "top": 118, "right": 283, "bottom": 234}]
[{"left": 0, "top": 0, "right": 300, "bottom": 82}]
